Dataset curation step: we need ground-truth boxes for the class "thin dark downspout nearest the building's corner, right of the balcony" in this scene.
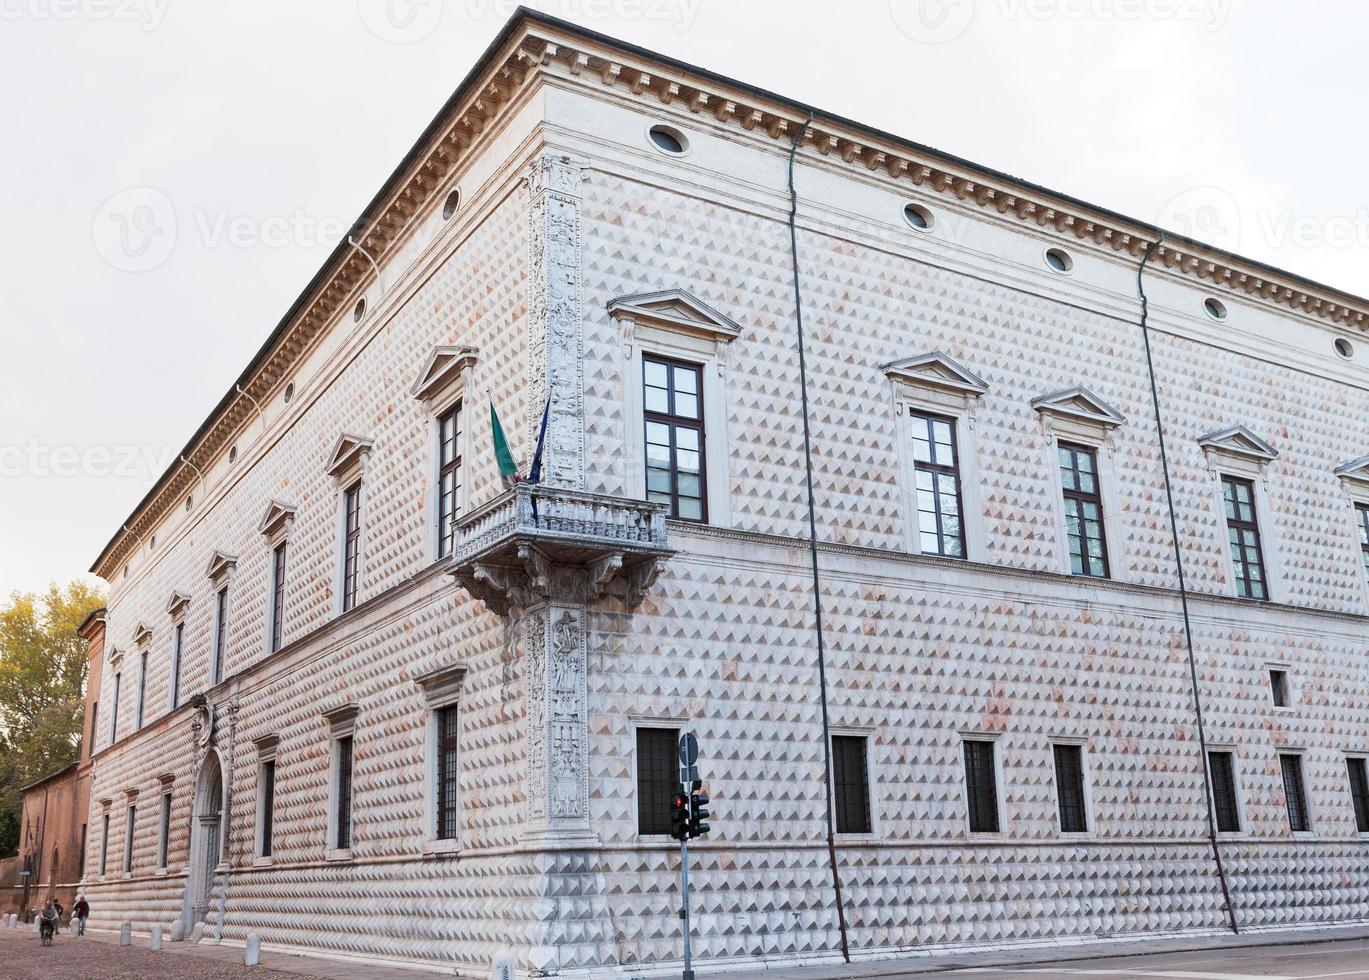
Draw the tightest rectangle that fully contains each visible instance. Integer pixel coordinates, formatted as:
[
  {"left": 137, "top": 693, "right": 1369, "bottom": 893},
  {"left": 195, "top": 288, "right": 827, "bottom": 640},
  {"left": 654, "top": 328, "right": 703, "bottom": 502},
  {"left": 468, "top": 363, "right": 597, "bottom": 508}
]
[{"left": 789, "top": 112, "right": 852, "bottom": 962}]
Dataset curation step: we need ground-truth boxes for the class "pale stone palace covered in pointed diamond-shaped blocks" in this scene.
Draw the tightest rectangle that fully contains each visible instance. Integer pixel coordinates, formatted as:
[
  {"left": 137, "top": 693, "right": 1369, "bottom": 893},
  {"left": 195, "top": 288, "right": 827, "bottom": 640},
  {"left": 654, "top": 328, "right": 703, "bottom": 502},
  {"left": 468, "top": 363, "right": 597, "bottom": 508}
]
[{"left": 86, "top": 12, "right": 1369, "bottom": 975}]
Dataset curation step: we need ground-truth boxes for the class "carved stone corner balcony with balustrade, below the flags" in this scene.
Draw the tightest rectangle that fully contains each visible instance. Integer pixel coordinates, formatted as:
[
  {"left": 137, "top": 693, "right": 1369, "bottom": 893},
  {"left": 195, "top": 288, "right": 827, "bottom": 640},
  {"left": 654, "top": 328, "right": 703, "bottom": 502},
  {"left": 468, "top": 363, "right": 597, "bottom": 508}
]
[{"left": 452, "top": 483, "right": 675, "bottom": 616}]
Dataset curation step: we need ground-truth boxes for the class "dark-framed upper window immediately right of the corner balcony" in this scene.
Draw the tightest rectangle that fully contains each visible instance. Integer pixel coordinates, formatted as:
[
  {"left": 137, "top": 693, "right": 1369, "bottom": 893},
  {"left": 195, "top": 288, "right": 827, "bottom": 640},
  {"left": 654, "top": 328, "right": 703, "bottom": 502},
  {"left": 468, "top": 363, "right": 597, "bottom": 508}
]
[{"left": 642, "top": 357, "right": 708, "bottom": 521}]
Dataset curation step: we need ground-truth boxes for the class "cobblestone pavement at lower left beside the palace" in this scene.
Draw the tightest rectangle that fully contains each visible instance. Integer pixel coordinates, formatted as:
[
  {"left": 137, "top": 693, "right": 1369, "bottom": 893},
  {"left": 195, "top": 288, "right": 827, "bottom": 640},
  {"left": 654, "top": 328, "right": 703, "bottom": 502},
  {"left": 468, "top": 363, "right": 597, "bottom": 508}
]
[{"left": 0, "top": 924, "right": 300, "bottom": 980}]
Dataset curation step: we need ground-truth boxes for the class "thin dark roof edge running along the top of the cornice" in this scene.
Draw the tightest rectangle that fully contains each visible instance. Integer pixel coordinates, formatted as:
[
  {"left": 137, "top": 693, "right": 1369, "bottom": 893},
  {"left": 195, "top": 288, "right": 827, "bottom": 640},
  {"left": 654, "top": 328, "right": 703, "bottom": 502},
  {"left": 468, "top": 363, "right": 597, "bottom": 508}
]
[{"left": 89, "top": 7, "right": 1369, "bottom": 575}]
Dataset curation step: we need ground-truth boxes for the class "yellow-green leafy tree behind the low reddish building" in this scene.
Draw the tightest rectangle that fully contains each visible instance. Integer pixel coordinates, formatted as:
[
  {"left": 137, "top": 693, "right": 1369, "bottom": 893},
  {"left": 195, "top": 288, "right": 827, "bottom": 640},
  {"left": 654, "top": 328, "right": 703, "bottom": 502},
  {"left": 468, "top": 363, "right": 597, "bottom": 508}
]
[{"left": 0, "top": 582, "right": 104, "bottom": 854}]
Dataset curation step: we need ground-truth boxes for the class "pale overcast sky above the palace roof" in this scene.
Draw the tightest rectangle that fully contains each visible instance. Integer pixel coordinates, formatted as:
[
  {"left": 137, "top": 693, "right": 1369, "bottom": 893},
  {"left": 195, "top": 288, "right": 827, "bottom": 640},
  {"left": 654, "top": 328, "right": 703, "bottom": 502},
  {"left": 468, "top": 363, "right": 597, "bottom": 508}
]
[{"left": 0, "top": 0, "right": 1369, "bottom": 597}]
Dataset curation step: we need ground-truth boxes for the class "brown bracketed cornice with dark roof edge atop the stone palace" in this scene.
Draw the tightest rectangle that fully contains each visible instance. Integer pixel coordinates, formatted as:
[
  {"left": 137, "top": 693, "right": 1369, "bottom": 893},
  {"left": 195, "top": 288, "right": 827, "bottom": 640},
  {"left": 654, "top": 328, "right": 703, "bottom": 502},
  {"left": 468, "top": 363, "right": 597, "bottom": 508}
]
[{"left": 90, "top": 8, "right": 1369, "bottom": 580}]
